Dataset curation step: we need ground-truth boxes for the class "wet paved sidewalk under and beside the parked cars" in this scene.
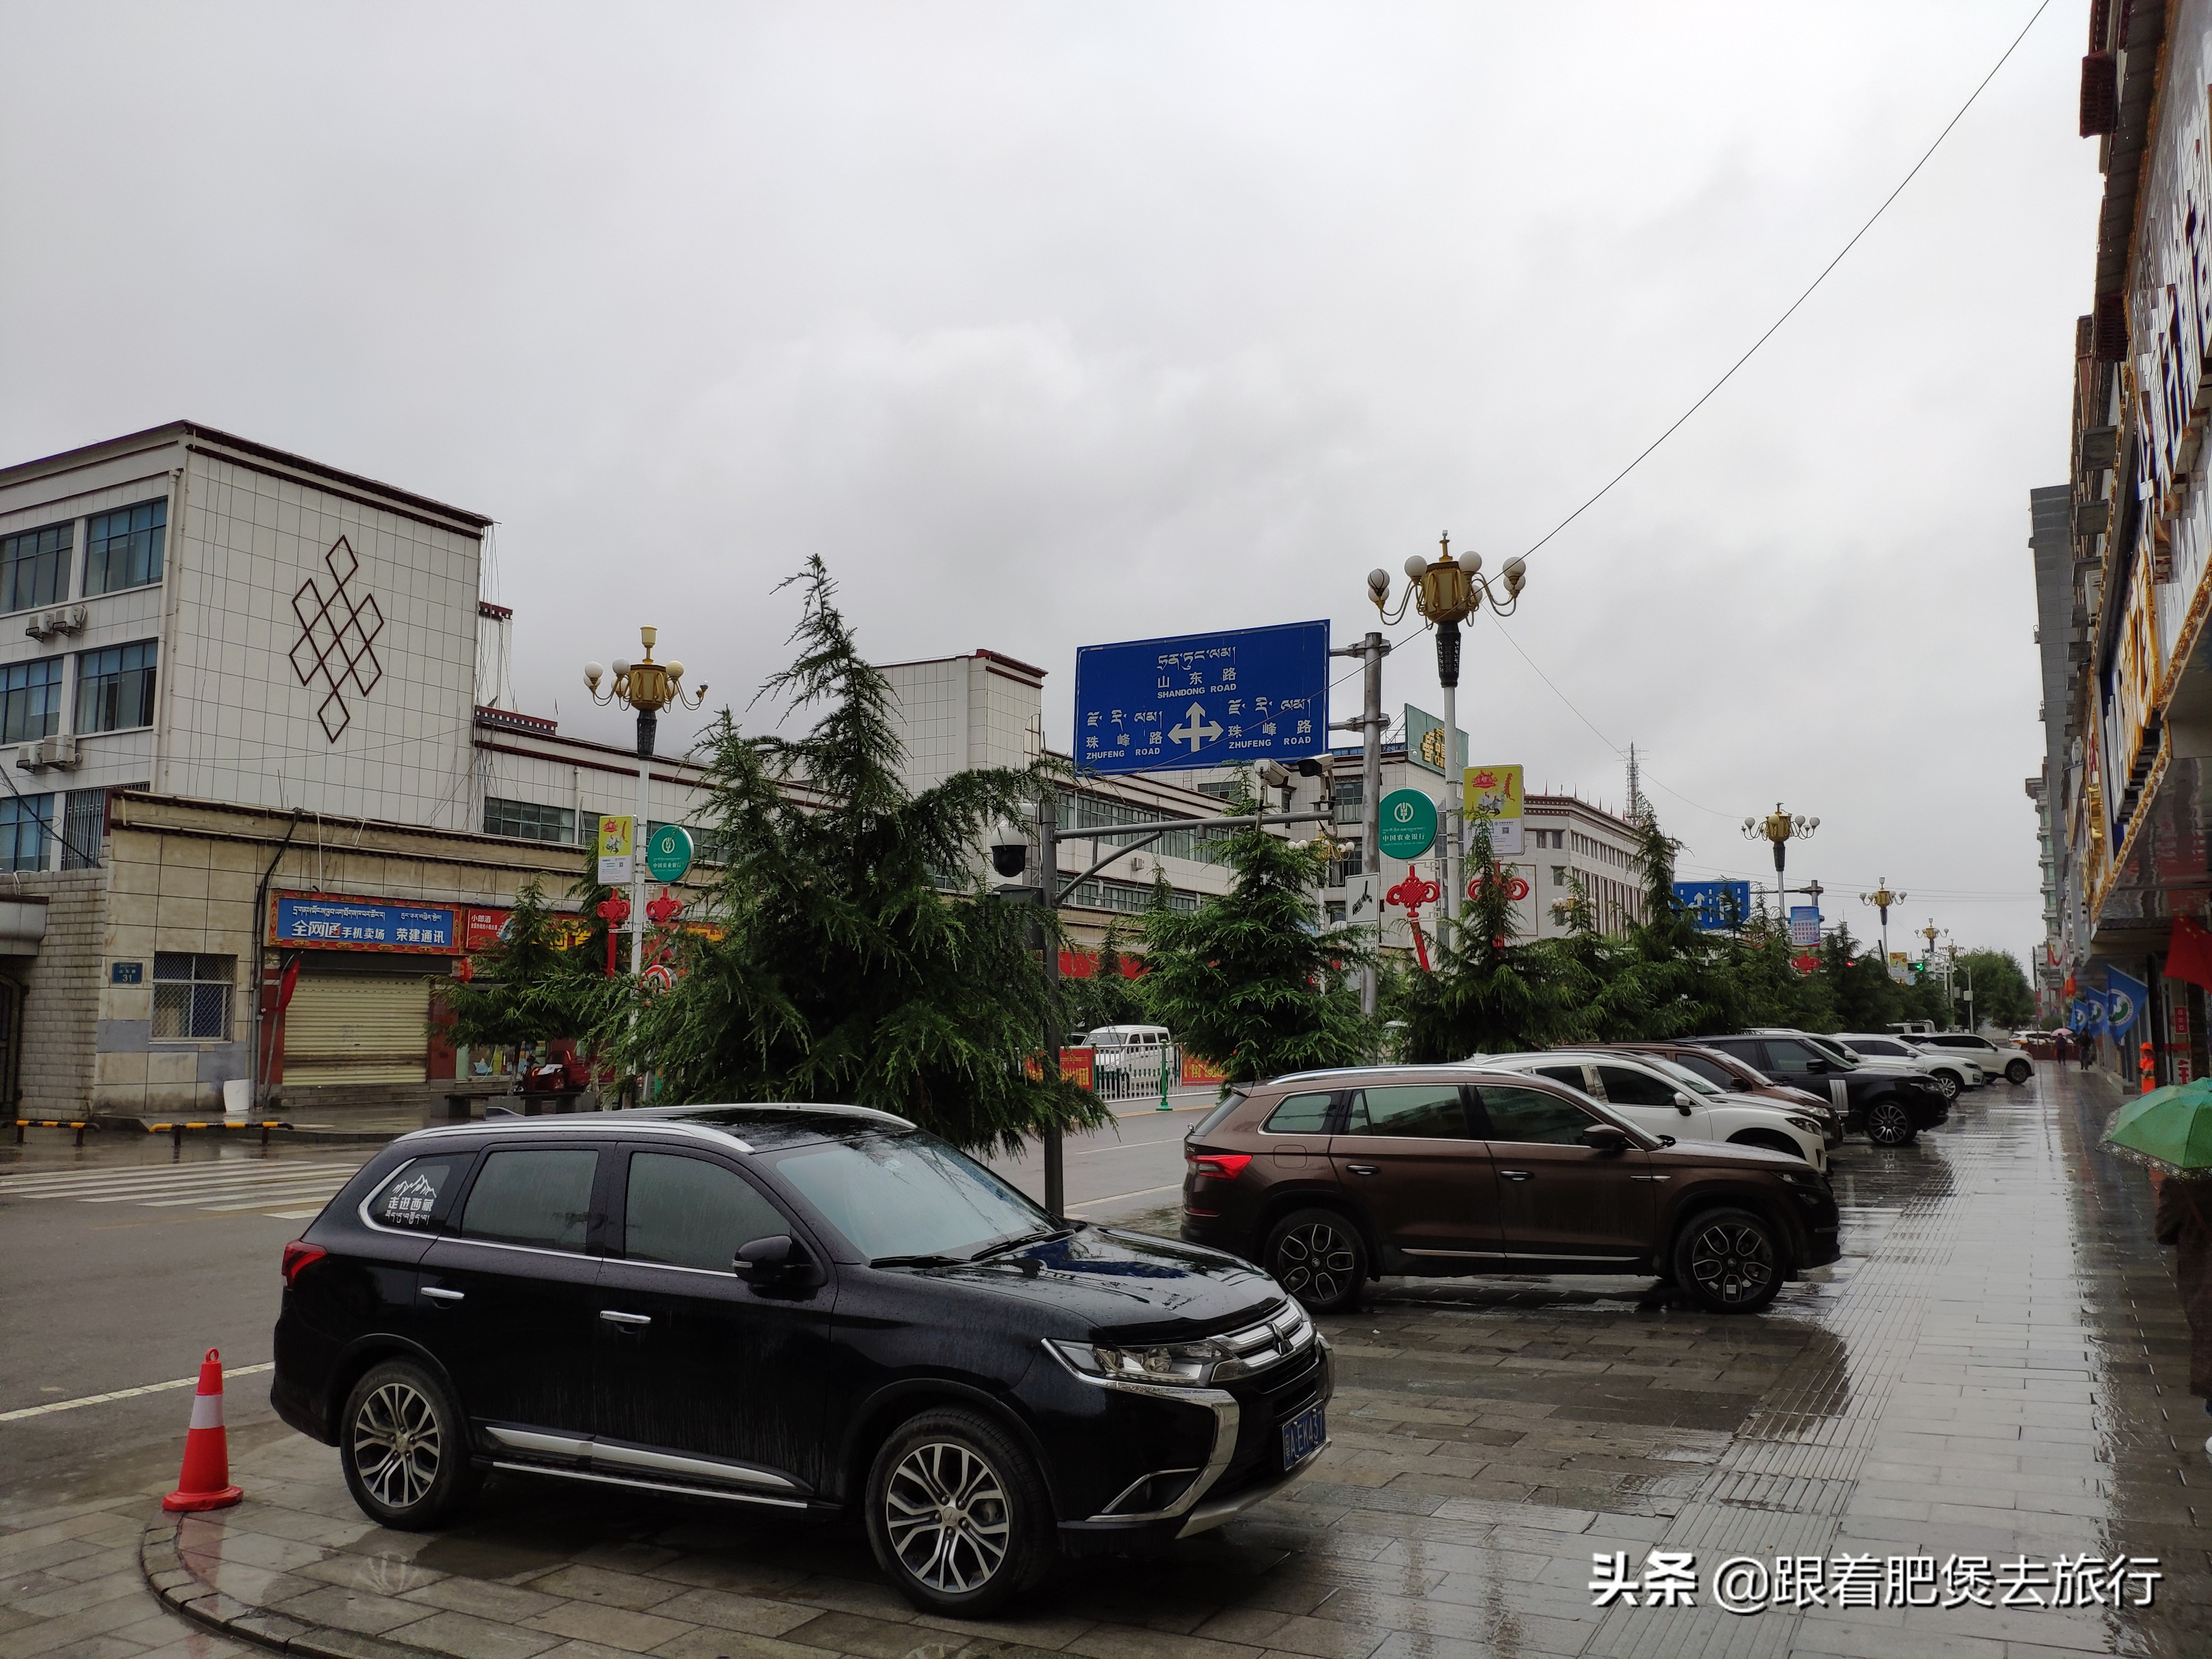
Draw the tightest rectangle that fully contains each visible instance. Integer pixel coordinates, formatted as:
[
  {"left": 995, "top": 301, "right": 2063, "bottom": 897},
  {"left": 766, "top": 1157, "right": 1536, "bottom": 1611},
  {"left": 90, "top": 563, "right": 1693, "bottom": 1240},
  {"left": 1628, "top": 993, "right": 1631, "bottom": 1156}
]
[{"left": 0, "top": 1066, "right": 2212, "bottom": 1659}]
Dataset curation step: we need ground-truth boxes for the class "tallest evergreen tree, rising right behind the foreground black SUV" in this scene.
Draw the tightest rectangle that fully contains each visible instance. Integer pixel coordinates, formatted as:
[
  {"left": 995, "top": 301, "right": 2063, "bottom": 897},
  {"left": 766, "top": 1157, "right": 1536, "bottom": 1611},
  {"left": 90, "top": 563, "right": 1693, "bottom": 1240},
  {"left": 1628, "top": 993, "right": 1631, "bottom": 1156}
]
[{"left": 602, "top": 557, "right": 1106, "bottom": 1150}]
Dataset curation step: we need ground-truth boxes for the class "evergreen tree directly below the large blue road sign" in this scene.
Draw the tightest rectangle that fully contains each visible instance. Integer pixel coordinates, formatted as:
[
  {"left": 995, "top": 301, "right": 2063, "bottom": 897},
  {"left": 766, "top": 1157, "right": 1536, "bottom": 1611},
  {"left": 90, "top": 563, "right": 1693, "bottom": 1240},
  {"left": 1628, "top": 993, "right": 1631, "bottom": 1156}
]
[{"left": 1137, "top": 785, "right": 1374, "bottom": 1084}]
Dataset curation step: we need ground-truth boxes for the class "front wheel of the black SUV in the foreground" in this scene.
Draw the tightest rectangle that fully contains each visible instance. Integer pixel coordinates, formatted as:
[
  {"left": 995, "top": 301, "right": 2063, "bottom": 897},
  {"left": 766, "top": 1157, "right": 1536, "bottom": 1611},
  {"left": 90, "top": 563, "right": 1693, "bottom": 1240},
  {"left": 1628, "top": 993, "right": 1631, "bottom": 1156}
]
[{"left": 867, "top": 1409, "right": 1057, "bottom": 1619}]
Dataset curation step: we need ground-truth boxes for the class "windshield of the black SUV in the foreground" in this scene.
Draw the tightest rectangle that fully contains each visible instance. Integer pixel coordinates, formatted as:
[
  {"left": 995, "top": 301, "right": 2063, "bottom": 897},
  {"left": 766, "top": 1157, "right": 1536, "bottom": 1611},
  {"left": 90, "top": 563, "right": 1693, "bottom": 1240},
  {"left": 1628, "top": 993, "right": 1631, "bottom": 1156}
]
[{"left": 774, "top": 1135, "right": 1057, "bottom": 1261}]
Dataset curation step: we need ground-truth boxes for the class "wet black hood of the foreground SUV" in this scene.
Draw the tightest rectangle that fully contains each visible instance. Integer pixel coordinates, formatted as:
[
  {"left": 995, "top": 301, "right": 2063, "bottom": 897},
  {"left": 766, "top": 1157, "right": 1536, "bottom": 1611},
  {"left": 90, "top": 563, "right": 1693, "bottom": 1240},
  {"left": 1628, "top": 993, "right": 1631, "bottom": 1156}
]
[{"left": 931, "top": 1228, "right": 1283, "bottom": 1342}]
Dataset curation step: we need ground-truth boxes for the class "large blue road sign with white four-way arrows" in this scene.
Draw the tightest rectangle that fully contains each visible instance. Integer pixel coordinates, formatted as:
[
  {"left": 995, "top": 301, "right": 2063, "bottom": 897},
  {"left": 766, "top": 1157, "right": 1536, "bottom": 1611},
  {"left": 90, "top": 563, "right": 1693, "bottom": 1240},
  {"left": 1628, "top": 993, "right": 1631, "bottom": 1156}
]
[{"left": 1075, "top": 622, "right": 1329, "bottom": 772}]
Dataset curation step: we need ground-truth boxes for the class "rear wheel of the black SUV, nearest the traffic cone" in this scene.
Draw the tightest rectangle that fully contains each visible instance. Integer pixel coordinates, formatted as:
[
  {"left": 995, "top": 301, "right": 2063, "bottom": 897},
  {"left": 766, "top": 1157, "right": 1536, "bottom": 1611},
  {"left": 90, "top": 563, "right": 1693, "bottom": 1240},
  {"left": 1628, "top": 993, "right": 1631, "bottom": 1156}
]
[{"left": 338, "top": 1361, "right": 482, "bottom": 1533}]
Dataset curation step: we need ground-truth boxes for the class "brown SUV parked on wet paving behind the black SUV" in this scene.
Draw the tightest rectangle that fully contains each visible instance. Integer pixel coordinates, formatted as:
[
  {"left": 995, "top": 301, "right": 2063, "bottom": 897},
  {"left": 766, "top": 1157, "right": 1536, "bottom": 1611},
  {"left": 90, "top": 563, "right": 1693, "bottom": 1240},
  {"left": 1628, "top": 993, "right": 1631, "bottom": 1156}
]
[{"left": 1183, "top": 1066, "right": 1841, "bottom": 1314}]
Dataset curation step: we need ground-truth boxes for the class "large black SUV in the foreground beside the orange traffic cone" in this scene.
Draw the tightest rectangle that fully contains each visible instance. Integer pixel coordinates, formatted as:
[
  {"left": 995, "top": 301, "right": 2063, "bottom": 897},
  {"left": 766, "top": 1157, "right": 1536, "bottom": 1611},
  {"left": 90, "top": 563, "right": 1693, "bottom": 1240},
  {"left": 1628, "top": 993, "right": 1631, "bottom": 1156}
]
[{"left": 270, "top": 1106, "right": 1331, "bottom": 1615}]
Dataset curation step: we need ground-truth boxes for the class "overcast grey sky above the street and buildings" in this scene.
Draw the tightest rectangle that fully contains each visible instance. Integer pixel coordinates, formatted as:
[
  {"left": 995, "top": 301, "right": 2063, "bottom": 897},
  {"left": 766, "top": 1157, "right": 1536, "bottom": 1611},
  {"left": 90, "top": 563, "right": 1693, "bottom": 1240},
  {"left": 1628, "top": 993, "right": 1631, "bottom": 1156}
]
[{"left": 0, "top": 0, "right": 2101, "bottom": 951}]
